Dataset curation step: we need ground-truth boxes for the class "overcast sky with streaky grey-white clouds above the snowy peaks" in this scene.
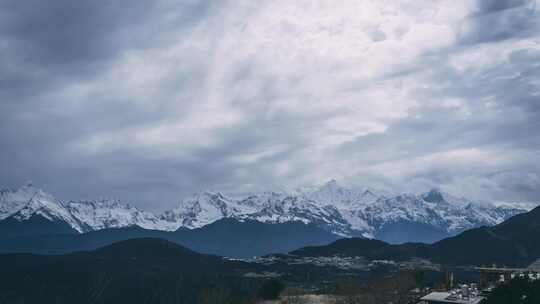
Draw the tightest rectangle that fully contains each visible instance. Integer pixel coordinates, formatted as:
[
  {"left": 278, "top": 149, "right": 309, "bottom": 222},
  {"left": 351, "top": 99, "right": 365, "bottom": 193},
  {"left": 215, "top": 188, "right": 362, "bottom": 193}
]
[{"left": 0, "top": 0, "right": 540, "bottom": 210}]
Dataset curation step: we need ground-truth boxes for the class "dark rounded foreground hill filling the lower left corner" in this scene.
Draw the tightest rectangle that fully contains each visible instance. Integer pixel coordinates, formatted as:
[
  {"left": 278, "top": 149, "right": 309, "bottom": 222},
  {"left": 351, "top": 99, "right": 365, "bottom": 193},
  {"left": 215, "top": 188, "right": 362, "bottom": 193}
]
[{"left": 0, "top": 238, "right": 264, "bottom": 304}]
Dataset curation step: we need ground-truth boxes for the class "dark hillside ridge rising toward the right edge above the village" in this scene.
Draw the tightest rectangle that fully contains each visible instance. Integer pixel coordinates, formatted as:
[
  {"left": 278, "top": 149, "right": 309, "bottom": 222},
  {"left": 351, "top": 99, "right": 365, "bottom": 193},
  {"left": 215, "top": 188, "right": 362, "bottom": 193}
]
[{"left": 291, "top": 207, "right": 540, "bottom": 266}]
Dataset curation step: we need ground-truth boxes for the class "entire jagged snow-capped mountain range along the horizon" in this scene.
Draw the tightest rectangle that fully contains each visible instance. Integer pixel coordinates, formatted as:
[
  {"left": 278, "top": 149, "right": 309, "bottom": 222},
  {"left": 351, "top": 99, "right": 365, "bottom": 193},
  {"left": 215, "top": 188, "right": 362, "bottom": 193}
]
[{"left": 0, "top": 180, "right": 528, "bottom": 242}]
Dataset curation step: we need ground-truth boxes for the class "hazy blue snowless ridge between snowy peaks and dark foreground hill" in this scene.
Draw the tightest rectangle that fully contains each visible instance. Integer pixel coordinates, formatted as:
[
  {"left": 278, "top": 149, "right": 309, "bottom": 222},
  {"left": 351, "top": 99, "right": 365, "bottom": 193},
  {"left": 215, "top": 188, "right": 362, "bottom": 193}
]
[{"left": 0, "top": 219, "right": 338, "bottom": 257}]
